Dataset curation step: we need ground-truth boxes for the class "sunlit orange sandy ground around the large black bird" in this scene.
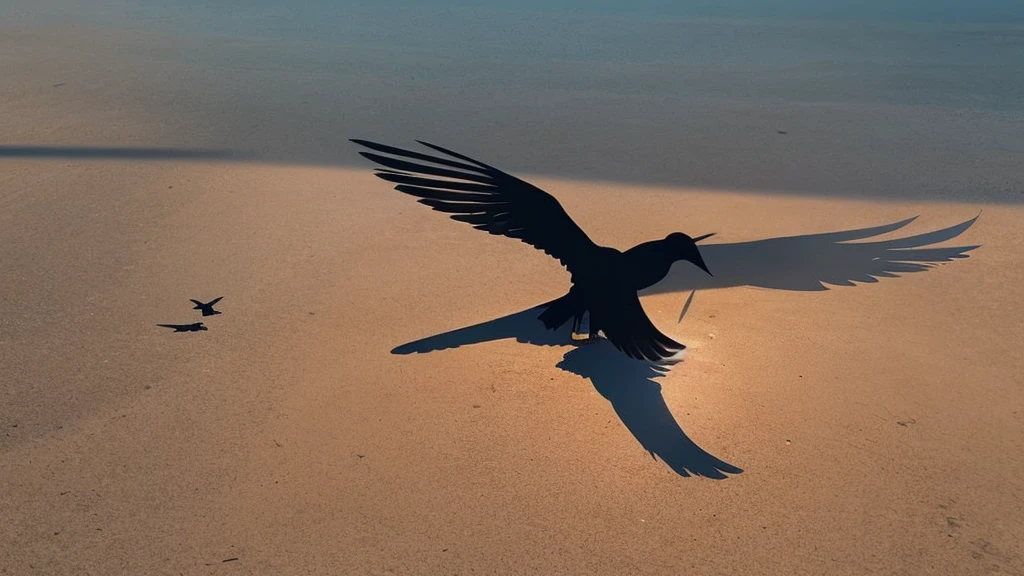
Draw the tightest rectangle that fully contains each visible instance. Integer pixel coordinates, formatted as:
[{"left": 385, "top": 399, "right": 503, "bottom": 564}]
[{"left": 0, "top": 149, "right": 1024, "bottom": 575}]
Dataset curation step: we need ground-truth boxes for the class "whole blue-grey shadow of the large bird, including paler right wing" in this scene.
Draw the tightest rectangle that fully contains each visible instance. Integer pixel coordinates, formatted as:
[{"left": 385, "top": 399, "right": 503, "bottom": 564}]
[{"left": 391, "top": 213, "right": 980, "bottom": 479}]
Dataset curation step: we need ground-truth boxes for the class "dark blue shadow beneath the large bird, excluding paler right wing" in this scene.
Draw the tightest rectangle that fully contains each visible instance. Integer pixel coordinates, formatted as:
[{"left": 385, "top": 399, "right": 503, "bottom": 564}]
[{"left": 391, "top": 304, "right": 742, "bottom": 480}]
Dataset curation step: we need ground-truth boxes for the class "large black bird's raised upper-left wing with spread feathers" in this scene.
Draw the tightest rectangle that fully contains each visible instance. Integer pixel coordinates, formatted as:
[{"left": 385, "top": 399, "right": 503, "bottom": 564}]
[{"left": 352, "top": 138, "right": 597, "bottom": 273}]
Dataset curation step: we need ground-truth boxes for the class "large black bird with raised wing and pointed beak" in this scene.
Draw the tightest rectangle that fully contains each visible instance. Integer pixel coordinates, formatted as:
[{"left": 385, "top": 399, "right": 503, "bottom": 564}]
[{"left": 352, "top": 139, "right": 712, "bottom": 362}]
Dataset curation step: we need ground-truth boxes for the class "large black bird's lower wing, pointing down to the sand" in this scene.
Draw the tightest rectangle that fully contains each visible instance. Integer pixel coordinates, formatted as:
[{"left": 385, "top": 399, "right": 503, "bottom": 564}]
[{"left": 590, "top": 281, "right": 686, "bottom": 362}]
